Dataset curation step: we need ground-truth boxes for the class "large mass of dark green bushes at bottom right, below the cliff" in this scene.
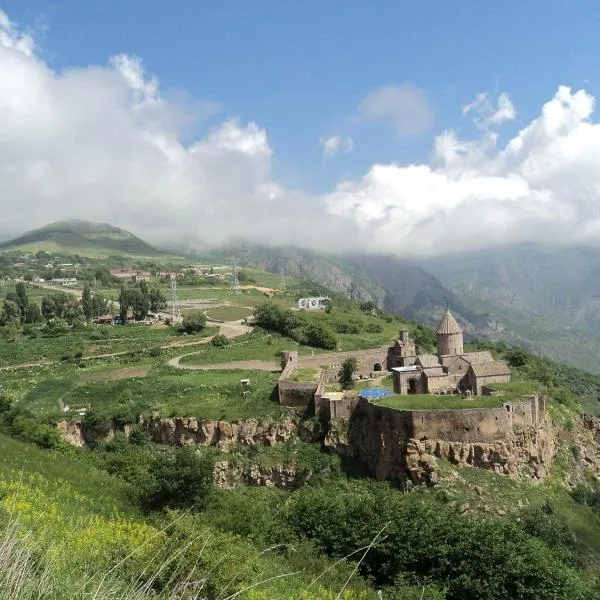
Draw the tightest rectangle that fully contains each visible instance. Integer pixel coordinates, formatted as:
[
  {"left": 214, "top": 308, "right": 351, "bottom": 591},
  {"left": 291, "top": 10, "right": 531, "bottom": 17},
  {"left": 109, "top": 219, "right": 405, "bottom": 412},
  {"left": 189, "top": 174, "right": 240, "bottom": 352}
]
[{"left": 283, "top": 485, "right": 594, "bottom": 600}]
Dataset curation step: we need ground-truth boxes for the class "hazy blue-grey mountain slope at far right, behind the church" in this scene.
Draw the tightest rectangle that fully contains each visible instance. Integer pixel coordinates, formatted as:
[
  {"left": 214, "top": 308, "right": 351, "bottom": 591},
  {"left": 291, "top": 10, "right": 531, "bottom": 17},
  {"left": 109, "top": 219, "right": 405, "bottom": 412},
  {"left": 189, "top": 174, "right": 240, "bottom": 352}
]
[{"left": 419, "top": 244, "right": 600, "bottom": 372}]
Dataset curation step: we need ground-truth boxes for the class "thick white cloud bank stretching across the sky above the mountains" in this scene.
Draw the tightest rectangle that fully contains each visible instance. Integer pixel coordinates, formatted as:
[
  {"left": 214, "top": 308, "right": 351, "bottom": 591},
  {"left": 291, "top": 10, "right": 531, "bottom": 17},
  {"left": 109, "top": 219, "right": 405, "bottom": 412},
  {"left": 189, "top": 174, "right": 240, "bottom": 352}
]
[{"left": 0, "top": 12, "right": 600, "bottom": 255}]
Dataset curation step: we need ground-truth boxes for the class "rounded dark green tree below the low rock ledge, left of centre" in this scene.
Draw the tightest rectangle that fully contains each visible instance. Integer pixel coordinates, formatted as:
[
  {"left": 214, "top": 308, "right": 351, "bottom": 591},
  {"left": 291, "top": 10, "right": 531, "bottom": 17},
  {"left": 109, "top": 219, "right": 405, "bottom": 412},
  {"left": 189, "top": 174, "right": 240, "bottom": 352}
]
[{"left": 140, "top": 446, "right": 213, "bottom": 510}]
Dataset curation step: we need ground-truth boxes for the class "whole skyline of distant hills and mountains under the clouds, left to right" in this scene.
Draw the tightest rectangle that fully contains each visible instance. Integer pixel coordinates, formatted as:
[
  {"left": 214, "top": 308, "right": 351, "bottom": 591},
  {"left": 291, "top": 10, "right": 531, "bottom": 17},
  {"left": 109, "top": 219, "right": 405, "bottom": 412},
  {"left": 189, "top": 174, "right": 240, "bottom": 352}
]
[{"left": 0, "top": 221, "right": 600, "bottom": 372}]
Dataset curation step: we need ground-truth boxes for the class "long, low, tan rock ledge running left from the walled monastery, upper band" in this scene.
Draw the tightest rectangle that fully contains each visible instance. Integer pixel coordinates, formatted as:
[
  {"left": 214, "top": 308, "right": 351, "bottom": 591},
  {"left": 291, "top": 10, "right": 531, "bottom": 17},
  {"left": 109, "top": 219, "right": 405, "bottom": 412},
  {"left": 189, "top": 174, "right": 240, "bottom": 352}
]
[{"left": 57, "top": 417, "right": 307, "bottom": 449}]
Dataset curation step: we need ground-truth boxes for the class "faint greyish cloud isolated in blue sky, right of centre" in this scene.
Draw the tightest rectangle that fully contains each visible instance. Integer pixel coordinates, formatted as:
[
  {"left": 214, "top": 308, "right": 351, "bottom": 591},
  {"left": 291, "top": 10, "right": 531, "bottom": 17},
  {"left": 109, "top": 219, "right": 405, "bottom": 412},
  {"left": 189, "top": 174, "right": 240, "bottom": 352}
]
[{"left": 358, "top": 83, "right": 434, "bottom": 137}]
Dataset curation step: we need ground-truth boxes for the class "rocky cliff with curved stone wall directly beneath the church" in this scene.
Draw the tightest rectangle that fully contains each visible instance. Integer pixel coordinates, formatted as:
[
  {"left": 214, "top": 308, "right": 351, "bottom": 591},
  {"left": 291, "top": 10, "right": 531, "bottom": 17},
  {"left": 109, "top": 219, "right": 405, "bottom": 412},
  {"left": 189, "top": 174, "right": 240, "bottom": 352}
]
[{"left": 325, "top": 399, "right": 556, "bottom": 485}]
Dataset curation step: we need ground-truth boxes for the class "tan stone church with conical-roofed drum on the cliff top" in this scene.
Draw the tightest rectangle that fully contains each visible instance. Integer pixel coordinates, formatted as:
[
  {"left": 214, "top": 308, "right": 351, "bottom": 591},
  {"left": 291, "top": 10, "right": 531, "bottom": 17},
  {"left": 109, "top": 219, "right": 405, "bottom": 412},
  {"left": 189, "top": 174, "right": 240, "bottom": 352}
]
[{"left": 387, "top": 310, "right": 510, "bottom": 395}]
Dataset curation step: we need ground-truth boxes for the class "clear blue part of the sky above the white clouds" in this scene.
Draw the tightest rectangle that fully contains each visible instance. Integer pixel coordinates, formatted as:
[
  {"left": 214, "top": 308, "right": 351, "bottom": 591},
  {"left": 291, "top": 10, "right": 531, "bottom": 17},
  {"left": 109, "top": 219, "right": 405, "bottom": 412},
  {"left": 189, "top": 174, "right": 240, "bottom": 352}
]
[{"left": 0, "top": 0, "right": 600, "bottom": 191}]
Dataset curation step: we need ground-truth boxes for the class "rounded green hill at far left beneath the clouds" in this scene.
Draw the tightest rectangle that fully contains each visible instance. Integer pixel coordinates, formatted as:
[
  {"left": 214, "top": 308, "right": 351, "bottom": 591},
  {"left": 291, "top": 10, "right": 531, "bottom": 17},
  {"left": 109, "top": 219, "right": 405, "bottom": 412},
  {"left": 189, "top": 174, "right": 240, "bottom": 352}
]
[{"left": 0, "top": 220, "right": 160, "bottom": 257}]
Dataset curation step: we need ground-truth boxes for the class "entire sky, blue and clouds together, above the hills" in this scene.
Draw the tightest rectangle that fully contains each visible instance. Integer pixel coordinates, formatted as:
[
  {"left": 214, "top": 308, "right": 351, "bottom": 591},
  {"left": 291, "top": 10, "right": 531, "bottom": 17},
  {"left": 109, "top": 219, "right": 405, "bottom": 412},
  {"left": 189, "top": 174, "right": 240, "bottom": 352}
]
[{"left": 0, "top": 0, "right": 600, "bottom": 256}]
